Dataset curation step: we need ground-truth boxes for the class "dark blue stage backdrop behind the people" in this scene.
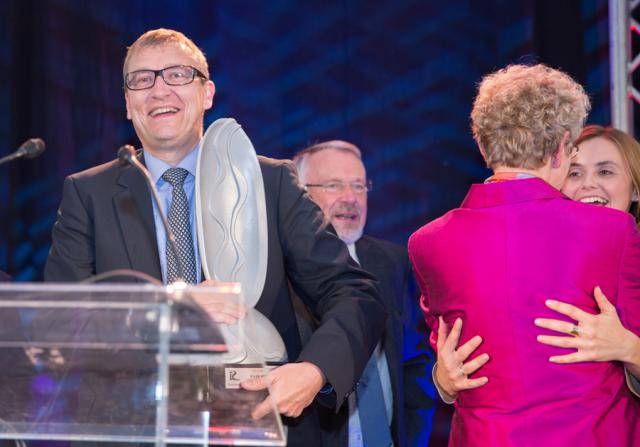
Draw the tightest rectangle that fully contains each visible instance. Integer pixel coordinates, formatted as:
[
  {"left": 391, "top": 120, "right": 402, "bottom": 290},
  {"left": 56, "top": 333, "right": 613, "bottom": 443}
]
[{"left": 0, "top": 0, "right": 610, "bottom": 445}]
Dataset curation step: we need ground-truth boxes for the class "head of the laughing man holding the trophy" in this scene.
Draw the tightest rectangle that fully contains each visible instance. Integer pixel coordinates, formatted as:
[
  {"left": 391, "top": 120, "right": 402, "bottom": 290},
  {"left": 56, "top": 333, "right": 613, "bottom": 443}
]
[{"left": 123, "top": 32, "right": 215, "bottom": 166}]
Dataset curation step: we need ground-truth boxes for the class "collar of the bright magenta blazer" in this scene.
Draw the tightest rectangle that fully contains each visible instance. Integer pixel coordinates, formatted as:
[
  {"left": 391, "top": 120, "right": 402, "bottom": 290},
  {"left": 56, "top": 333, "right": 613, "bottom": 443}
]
[{"left": 460, "top": 177, "right": 570, "bottom": 208}]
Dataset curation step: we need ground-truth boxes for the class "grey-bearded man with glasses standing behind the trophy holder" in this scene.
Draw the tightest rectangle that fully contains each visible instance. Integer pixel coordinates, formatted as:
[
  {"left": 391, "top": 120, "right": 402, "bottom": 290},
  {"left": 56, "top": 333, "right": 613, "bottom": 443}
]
[{"left": 293, "top": 140, "right": 435, "bottom": 447}]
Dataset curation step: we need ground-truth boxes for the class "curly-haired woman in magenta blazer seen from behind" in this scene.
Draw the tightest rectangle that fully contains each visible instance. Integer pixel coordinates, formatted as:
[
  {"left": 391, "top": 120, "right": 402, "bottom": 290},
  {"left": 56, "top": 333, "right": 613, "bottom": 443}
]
[{"left": 409, "top": 65, "right": 640, "bottom": 446}]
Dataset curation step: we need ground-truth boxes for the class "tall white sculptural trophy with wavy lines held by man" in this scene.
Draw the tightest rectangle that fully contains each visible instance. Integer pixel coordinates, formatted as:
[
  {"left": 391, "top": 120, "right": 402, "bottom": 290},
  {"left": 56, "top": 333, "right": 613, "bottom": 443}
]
[{"left": 196, "top": 118, "right": 287, "bottom": 363}]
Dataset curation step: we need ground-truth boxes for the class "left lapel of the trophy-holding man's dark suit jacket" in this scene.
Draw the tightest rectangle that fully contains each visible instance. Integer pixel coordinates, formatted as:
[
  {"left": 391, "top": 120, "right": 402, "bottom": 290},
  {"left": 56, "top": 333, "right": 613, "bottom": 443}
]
[{"left": 113, "top": 161, "right": 162, "bottom": 280}]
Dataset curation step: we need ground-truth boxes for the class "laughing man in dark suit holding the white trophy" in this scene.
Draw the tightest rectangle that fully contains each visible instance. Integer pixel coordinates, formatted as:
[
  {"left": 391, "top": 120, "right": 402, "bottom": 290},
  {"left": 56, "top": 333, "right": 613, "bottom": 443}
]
[{"left": 45, "top": 29, "right": 385, "bottom": 447}]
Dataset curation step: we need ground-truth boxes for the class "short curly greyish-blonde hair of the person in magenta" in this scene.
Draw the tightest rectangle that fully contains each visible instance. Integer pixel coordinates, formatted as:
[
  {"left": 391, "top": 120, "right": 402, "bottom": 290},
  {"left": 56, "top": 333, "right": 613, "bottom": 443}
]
[{"left": 471, "top": 64, "right": 591, "bottom": 169}]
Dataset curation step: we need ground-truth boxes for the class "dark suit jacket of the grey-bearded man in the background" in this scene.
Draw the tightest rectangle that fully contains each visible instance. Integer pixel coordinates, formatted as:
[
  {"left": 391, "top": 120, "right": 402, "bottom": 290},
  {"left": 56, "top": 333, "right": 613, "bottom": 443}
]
[{"left": 319, "top": 236, "right": 435, "bottom": 447}]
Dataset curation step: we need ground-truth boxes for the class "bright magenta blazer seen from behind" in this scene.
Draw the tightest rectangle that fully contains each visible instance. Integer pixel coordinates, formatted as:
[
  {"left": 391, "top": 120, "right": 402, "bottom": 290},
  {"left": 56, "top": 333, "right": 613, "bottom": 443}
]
[{"left": 409, "top": 178, "right": 640, "bottom": 447}]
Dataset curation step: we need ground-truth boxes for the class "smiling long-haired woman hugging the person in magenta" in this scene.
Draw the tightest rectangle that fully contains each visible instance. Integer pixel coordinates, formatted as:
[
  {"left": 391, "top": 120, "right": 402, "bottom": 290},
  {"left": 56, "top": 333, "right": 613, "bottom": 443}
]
[{"left": 535, "top": 125, "right": 640, "bottom": 396}]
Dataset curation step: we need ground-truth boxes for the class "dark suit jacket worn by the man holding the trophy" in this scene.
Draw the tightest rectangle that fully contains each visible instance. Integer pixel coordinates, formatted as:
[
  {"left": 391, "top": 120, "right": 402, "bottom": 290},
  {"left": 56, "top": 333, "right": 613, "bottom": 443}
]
[{"left": 45, "top": 157, "right": 385, "bottom": 446}]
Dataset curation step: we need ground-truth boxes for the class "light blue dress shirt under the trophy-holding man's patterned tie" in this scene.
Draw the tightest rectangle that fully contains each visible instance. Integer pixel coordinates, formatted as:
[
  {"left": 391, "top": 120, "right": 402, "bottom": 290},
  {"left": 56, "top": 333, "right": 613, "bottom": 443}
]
[{"left": 143, "top": 148, "right": 202, "bottom": 284}]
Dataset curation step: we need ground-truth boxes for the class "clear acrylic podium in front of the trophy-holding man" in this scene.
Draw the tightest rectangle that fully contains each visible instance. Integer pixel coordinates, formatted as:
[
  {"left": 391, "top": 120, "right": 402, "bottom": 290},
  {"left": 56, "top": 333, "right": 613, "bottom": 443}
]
[{"left": 0, "top": 283, "right": 285, "bottom": 446}]
